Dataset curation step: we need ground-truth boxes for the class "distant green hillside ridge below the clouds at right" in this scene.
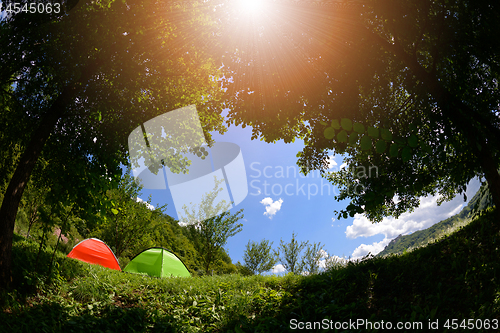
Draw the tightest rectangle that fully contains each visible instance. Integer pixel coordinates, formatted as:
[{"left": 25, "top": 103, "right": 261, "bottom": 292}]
[{"left": 376, "top": 186, "right": 490, "bottom": 257}]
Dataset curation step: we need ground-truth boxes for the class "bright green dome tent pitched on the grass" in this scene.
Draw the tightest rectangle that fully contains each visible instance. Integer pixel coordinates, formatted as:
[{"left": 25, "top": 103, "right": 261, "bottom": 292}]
[{"left": 123, "top": 247, "right": 191, "bottom": 277}]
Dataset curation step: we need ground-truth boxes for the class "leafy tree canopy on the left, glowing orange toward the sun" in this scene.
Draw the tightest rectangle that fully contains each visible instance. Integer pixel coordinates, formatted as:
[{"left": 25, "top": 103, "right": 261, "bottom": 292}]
[{"left": 0, "top": 0, "right": 229, "bottom": 286}]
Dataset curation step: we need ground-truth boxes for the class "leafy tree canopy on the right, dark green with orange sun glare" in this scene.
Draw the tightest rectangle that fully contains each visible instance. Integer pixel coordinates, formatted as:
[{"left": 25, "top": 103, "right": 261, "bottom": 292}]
[{"left": 217, "top": 0, "right": 500, "bottom": 221}]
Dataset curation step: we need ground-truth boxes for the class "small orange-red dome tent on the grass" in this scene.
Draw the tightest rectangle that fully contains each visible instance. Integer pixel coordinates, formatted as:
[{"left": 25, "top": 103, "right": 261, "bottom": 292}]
[{"left": 68, "top": 238, "right": 121, "bottom": 271}]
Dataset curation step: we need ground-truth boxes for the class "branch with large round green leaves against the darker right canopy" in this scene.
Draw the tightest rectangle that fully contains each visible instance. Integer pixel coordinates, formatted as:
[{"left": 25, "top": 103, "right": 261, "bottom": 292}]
[{"left": 320, "top": 118, "right": 424, "bottom": 162}]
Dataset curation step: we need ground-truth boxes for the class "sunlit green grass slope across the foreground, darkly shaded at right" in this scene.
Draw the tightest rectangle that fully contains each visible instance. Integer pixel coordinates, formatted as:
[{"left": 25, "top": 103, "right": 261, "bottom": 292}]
[{"left": 0, "top": 211, "right": 500, "bottom": 333}]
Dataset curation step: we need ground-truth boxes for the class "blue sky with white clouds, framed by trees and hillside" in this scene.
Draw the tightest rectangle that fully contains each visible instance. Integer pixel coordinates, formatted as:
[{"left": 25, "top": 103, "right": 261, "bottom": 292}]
[{"left": 137, "top": 111, "right": 479, "bottom": 273}]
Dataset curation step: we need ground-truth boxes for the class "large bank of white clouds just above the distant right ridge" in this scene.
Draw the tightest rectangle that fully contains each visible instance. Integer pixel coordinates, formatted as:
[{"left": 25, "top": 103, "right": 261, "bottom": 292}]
[{"left": 345, "top": 180, "right": 479, "bottom": 259}]
